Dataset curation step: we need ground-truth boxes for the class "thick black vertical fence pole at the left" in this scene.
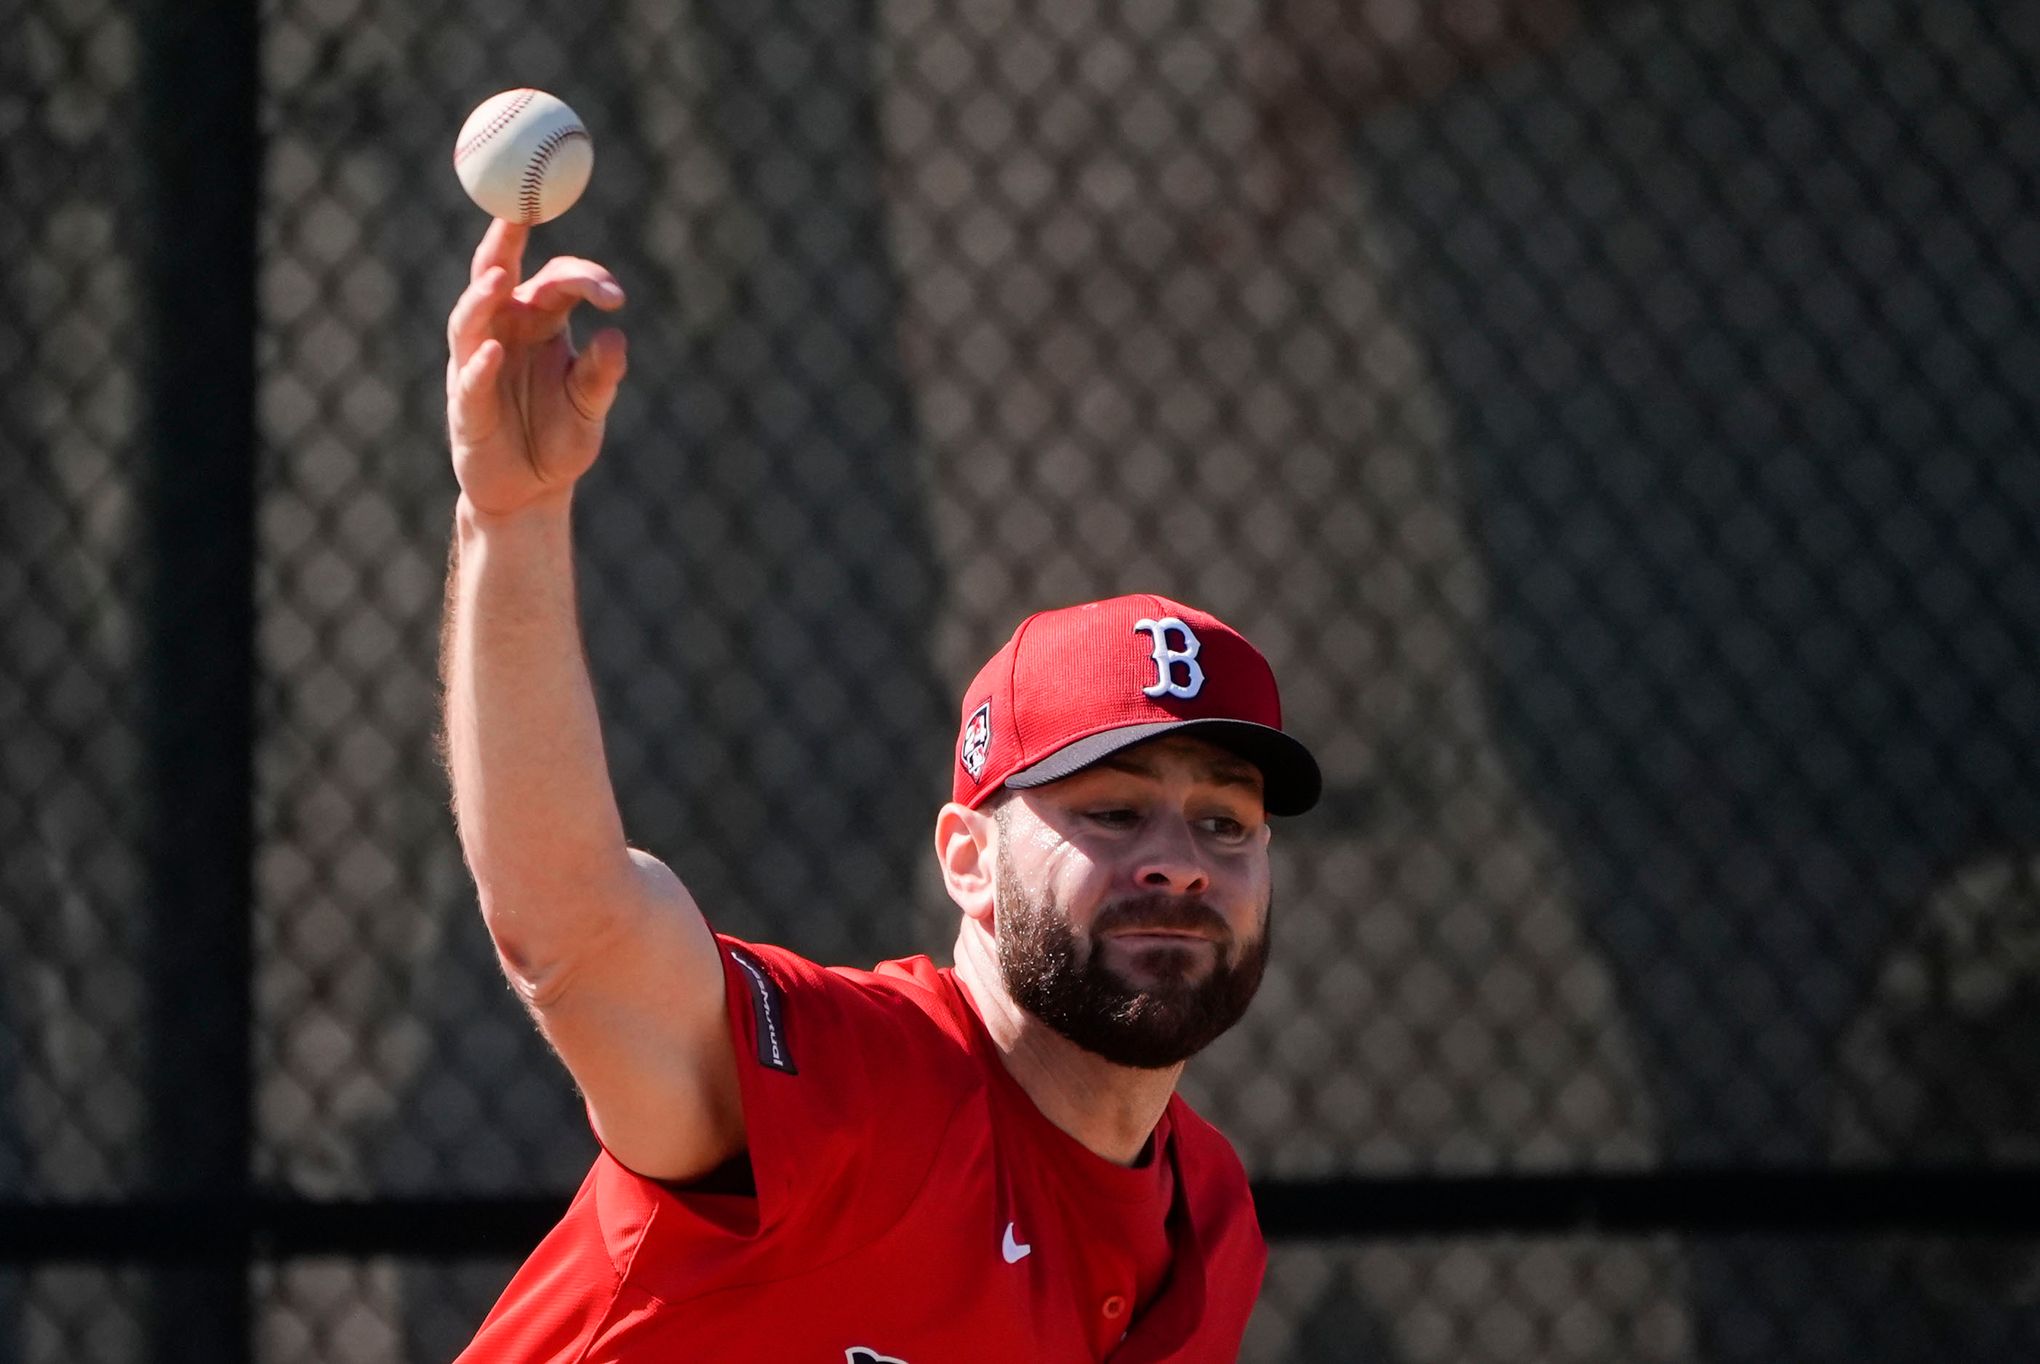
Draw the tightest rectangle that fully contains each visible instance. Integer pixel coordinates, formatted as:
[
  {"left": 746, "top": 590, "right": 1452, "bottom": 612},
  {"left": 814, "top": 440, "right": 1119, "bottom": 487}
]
[{"left": 135, "top": 0, "right": 259, "bottom": 1364}]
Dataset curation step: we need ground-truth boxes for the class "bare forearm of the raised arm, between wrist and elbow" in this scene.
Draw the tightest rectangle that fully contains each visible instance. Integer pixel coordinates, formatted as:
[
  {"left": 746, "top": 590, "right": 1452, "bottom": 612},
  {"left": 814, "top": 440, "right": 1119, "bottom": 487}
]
[{"left": 441, "top": 497, "right": 634, "bottom": 989}]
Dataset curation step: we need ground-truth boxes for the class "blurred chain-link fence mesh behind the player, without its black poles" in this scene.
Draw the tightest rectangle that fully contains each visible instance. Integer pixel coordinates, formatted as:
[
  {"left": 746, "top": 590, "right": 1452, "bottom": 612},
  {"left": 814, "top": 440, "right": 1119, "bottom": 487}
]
[{"left": 0, "top": 0, "right": 2040, "bottom": 1364}]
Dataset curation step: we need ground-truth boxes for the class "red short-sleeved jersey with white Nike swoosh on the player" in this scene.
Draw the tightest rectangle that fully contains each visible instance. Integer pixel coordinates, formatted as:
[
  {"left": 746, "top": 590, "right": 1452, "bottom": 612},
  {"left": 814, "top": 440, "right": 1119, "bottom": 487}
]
[{"left": 461, "top": 938, "right": 1267, "bottom": 1364}]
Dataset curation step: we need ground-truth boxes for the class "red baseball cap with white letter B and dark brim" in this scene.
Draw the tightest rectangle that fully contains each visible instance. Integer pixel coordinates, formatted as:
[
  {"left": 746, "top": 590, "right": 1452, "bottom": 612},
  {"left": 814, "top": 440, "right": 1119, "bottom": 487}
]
[{"left": 955, "top": 593, "right": 1324, "bottom": 816}]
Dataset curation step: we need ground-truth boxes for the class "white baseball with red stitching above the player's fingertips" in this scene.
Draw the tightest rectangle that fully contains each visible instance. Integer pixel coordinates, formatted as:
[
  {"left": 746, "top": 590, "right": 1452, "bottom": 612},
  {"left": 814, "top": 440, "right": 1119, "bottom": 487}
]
[{"left": 453, "top": 90, "right": 596, "bottom": 226}]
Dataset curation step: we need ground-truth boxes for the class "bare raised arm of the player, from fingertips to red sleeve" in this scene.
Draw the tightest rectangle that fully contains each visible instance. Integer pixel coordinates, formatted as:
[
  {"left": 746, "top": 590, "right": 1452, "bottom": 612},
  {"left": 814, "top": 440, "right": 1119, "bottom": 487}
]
[{"left": 441, "top": 222, "right": 745, "bottom": 1178}]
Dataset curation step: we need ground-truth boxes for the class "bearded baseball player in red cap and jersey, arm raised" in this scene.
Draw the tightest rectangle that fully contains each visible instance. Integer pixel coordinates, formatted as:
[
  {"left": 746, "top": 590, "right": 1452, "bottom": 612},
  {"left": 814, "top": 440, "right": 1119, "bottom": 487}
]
[{"left": 445, "top": 222, "right": 1320, "bottom": 1364}]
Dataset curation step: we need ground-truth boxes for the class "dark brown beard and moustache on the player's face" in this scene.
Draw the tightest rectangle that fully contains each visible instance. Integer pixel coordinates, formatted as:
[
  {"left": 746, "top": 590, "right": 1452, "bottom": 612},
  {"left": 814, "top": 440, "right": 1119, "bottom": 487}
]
[{"left": 998, "top": 846, "right": 1273, "bottom": 1070}]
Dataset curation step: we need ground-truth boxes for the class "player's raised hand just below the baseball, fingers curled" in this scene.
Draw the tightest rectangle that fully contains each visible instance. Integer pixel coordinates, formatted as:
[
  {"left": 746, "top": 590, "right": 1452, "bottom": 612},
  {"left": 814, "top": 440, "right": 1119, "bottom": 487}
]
[{"left": 447, "top": 220, "right": 626, "bottom": 516}]
